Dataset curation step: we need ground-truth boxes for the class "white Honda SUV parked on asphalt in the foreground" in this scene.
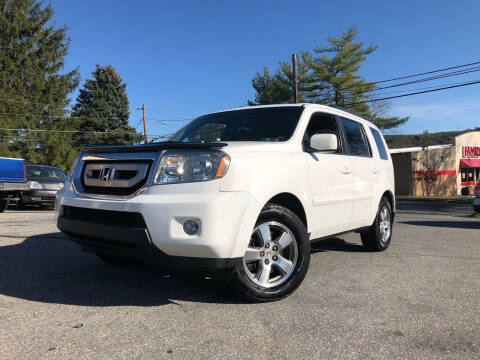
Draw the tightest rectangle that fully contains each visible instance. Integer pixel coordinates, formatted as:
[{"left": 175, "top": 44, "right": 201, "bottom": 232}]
[{"left": 56, "top": 104, "right": 395, "bottom": 301}]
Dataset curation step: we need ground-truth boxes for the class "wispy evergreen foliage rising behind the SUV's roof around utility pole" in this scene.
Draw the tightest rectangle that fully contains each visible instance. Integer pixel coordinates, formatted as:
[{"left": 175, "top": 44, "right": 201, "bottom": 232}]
[{"left": 249, "top": 26, "right": 408, "bottom": 129}]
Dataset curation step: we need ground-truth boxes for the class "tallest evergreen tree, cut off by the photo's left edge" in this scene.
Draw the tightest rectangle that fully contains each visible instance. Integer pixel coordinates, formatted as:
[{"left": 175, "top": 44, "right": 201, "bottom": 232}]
[{"left": 0, "top": 0, "right": 78, "bottom": 169}]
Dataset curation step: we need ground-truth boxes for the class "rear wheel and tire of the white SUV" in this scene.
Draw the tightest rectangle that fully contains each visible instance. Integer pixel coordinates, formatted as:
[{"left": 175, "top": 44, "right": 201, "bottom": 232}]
[{"left": 360, "top": 197, "right": 393, "bottom": 251}]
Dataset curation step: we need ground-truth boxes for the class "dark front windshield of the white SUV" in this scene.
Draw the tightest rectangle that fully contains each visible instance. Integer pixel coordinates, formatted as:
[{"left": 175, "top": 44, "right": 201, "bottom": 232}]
[{"left": 169, "top": 106, "right": 303, "bottom": 142}]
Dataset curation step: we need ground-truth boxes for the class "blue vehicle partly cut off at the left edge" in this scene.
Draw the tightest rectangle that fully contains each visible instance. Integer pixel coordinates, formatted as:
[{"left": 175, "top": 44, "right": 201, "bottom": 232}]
[{"left": 0, "top": 158, "right": 30, "bottom": 212}]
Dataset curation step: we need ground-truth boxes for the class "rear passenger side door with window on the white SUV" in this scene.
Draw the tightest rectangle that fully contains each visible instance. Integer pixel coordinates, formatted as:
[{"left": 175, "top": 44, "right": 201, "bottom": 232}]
[{"left": 340, "top": 117, "right": 379, "bottom": 229}]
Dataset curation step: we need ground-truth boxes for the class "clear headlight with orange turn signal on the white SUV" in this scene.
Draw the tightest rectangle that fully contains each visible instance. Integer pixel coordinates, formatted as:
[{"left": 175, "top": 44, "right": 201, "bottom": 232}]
[{"left": 153, "top": 150, "right": 230, "bottom": 184}]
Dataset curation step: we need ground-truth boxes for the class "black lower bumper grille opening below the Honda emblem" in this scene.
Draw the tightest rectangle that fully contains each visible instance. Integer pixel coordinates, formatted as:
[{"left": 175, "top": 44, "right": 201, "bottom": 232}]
[{"left": 63, "top": 205, "right": 147, "bottom": 229}]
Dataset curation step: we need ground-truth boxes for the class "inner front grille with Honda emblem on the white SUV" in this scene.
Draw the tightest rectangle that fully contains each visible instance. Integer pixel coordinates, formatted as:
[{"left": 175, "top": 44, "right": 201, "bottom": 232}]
[{"left": 81, "top": 160, "right": 153, "bottom": 195}]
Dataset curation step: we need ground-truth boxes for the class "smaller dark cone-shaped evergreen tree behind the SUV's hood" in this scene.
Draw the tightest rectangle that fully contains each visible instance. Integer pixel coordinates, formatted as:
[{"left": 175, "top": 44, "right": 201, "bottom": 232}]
[{"left": 72, "top": 65, "right": 141, "bottom": 147}]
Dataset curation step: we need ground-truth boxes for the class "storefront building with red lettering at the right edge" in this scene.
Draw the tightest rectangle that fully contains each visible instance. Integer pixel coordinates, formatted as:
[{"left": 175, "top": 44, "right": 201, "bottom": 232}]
[{"left": 390, "top": 131, "right": 480, "bottom": 196}]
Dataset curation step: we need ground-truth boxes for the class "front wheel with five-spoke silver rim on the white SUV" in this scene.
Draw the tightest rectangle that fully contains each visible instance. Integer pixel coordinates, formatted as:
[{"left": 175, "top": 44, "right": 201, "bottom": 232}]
[{"left": 232, "top": 203, "right": 310, "bottom": 302}]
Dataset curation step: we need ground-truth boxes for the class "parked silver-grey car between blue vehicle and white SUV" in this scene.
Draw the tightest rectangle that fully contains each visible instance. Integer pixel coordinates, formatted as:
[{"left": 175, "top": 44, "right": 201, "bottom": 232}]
[{"left": 17, "top": 165, "right": 67, "bottom": 209}]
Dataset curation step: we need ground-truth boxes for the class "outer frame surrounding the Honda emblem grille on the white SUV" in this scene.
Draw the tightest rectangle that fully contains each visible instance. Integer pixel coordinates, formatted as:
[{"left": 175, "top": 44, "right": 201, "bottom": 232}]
[{"left": 72, "top": 151, "right": 163, "bottom": 200}]
